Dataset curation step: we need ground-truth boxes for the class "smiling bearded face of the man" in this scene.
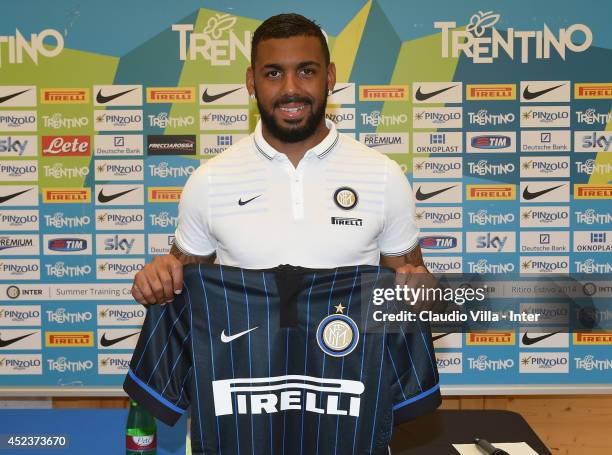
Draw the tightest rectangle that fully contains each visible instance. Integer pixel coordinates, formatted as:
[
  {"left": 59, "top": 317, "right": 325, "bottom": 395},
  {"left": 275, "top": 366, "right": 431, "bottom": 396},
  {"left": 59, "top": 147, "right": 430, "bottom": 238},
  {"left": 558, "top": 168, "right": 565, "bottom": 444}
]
[{"left": 247, "top": 36, "right": 335, "bottom": 143}]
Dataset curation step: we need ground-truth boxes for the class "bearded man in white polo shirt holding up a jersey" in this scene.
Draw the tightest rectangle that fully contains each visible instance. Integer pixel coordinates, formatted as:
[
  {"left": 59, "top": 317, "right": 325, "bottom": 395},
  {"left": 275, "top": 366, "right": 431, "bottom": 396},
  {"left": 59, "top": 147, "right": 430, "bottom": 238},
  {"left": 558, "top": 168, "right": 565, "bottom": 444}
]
[{"left": 132, "top": 14, "right": 427, "bottom": 304}]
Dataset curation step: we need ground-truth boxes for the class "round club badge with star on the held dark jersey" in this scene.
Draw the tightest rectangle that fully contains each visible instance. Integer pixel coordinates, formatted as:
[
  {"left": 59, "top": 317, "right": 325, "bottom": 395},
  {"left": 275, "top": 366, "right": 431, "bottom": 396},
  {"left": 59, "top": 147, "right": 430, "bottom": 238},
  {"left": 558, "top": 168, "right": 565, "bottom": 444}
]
[{"left": 317, "top": 303, "right": 359, "bottom": 357}]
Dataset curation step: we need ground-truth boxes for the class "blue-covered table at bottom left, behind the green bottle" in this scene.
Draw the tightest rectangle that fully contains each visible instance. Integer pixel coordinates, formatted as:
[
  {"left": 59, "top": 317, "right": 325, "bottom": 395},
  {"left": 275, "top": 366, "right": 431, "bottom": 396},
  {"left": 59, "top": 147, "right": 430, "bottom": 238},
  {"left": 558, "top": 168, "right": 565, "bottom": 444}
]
[{"left": 0, "top": 409, "right": 187, "bottom": 455}]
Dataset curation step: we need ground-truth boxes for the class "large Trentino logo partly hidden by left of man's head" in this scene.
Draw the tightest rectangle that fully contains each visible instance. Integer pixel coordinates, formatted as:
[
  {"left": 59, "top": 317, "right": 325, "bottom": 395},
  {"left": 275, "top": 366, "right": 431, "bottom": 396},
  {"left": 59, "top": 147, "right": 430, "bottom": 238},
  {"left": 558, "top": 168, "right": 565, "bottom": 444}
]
[{"left": 172, "top": 14, "right": 252, "bottom": 66}]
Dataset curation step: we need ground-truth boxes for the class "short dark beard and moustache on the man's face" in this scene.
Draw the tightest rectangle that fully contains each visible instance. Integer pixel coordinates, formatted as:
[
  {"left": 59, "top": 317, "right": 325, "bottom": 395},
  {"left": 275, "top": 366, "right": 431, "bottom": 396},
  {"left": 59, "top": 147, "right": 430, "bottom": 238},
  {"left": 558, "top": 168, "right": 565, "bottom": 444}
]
[{"left": 257, "top": 91, "right": 327, "bottom": 144}]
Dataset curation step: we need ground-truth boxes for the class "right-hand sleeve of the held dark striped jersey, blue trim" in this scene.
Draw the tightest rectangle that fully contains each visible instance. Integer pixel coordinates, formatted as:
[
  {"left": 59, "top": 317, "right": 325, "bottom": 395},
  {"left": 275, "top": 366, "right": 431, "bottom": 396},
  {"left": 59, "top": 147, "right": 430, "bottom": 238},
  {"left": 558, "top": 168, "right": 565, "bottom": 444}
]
[{"left": 387, "top": 323, "right": 442, "bottom": 425}]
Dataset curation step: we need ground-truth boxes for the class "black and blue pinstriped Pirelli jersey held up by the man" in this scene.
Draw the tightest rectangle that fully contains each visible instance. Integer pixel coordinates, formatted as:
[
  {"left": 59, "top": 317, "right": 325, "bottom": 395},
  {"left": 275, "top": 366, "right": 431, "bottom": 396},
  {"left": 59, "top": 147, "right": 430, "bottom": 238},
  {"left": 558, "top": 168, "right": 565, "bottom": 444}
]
[{"left": 124, "top": 265, "right": 441, "bottom": 455}]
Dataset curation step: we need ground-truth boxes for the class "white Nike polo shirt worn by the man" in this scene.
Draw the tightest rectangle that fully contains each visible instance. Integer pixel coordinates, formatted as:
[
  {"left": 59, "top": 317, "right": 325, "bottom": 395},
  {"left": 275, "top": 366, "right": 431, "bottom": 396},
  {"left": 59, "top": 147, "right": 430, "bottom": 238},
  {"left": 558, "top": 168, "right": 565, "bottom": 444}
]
[{"left": 175, "top": 121, "right": 418, "bottom": 269}]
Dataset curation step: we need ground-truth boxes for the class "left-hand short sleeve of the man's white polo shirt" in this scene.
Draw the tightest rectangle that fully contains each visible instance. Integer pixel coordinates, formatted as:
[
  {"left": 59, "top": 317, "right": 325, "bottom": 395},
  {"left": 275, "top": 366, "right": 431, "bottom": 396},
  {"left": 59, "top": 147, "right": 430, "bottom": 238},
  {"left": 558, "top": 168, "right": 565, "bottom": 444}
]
[{"left": 174, "top": 165, "right": 217, "bottom": 256}]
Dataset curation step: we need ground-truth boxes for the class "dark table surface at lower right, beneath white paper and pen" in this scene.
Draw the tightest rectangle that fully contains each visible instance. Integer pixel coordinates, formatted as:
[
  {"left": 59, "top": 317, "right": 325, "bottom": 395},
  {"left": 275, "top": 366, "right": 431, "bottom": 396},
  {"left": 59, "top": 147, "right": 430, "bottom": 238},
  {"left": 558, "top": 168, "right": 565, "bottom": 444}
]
[{"left": 391, "top": 410, "right": 551, "bottom": 455}]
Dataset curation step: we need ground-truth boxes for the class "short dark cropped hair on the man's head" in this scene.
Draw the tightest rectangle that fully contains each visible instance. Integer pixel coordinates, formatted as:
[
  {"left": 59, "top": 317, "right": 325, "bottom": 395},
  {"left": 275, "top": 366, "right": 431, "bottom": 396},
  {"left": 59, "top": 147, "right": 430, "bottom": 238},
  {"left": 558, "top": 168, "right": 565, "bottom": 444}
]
[{"left": 251, "top": 13, "right": 329, "bottom": 67}]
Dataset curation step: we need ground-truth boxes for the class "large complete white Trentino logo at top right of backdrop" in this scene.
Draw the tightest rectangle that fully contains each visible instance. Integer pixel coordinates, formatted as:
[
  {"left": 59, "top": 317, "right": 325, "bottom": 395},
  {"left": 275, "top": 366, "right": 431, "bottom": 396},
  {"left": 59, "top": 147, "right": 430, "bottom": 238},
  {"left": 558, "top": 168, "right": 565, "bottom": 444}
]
[{"left": 434, "top": 11, "right": 593, "bottom": 63}]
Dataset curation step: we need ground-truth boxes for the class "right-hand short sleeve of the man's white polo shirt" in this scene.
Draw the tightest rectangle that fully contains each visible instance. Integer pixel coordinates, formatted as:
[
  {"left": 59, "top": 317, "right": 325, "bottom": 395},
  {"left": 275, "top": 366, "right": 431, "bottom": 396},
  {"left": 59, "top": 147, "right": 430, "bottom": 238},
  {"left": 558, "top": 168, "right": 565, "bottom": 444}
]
[{"left": 378, "top": 159, "right": 419, "bottom": 256}]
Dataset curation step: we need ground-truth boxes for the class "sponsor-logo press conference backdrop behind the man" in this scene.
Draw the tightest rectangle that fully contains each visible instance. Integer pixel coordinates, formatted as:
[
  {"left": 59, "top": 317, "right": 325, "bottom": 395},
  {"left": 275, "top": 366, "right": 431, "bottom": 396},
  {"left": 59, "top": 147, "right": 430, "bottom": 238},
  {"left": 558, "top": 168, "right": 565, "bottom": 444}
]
[{"left": 0, "top": 0, "right": 612, "bottom": 393}]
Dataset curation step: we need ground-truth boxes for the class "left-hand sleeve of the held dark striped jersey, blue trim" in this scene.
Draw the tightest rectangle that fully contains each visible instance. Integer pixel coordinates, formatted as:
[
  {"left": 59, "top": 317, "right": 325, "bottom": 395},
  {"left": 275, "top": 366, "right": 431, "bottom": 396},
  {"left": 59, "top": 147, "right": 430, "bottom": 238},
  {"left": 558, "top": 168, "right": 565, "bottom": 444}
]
[{"left": 123, "top": 295, "right": 193, "bottom": 425}]
